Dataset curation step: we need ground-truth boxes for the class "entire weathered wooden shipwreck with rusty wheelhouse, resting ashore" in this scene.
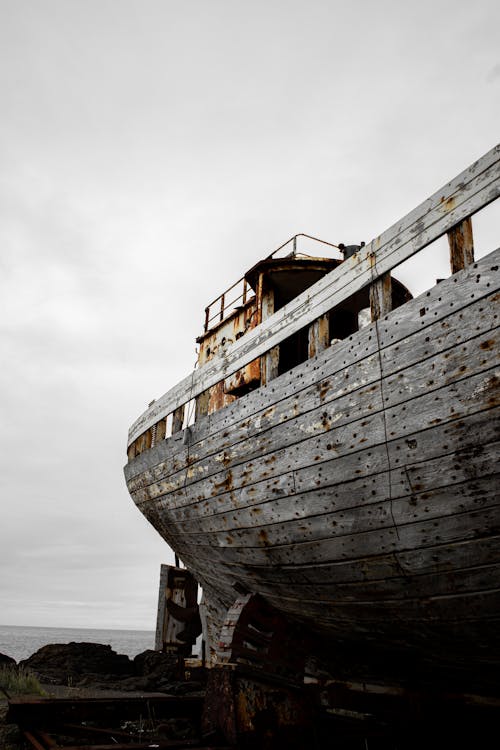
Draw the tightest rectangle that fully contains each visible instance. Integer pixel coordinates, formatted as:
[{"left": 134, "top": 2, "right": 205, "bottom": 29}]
[{"left": 125, "top": 146, "right": 500, "bottom": 704}]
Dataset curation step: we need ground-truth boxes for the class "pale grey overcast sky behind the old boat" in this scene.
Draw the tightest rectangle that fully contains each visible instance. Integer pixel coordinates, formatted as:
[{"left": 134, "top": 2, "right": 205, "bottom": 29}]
[{"left": 0, "top": 0, "right": 500, "bottom": 629}]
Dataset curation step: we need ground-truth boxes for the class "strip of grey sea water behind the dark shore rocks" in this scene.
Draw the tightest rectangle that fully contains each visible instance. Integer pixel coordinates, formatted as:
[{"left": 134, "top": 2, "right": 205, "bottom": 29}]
[{"left": 0, "top": 625, "right": 155, "bottom": 662}]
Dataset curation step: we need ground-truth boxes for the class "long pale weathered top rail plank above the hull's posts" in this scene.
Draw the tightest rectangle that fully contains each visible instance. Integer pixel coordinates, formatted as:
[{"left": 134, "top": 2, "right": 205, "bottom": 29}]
[{"left": 129, "top": 146, "right": 500, "bottom": 444}]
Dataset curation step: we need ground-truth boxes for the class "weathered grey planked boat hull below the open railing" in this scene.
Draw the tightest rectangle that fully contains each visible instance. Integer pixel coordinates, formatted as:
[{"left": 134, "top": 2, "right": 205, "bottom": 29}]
[{"left": 125, "top": 251, "right": 500, "bottom": 678}]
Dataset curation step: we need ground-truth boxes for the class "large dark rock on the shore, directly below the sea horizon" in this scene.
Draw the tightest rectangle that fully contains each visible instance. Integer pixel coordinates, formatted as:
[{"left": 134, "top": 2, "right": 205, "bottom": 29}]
[{"left": 20, "top": 643, "right": 134, "bottom": 684}]
